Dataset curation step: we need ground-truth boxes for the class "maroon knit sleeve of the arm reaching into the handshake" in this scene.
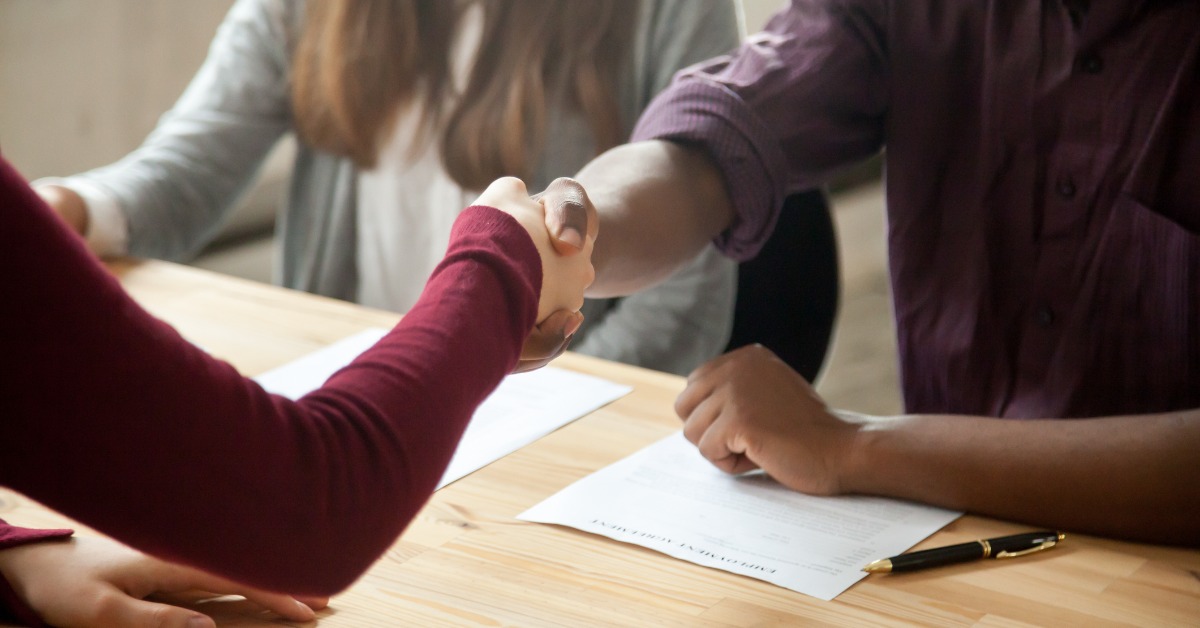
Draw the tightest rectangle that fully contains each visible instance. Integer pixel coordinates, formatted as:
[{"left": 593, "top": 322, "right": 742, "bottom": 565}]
[{"left": 0, "top": 160, "right": 541, "bottom": 594}]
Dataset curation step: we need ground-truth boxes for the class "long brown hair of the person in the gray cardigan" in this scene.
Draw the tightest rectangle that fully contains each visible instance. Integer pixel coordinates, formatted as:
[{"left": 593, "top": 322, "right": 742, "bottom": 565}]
[{"left": 292, "top": 0, "right": 638, "bottom": 190}]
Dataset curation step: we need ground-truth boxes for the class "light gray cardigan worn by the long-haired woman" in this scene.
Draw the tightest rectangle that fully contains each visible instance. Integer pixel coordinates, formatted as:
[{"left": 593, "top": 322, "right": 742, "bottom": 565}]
[{"left": 67, "top": 0, "right": 739, "bottom": 373}]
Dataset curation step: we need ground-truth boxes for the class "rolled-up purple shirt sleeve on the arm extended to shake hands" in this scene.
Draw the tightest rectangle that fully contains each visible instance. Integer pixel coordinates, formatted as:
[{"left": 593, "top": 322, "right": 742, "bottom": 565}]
[{"left": 632, "top": 0, "right": 887, "bottom": 261}]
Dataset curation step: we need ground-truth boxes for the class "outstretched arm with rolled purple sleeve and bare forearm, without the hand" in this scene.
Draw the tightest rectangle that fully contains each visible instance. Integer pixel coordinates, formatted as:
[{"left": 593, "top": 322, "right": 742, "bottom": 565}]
[{"left": 547, "top": 2, "right": 888, "bottom": 297}]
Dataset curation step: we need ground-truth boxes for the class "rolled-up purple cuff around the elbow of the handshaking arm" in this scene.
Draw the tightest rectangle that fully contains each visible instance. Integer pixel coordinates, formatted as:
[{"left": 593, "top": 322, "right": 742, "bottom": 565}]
[{"left": 632, "top": 76, "right": 787, "bottom": 262}]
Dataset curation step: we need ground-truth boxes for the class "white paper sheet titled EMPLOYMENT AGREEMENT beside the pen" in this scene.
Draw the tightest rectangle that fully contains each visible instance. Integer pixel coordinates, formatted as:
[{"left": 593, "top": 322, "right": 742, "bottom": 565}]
[{"left": 518, "top": 432, "right": 961, "bottom": 600}]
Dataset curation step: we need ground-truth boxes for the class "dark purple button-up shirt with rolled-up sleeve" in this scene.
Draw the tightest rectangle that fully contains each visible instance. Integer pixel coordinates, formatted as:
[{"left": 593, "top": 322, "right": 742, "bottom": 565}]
[{"left": 635, "top": 0, "right": 1200, "bottom": 418}]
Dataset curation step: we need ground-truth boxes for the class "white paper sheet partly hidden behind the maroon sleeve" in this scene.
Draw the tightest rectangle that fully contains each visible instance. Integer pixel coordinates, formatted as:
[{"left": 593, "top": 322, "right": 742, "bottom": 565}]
[{"left": 256, "top": 329, "right": 630, "bottom": 489}]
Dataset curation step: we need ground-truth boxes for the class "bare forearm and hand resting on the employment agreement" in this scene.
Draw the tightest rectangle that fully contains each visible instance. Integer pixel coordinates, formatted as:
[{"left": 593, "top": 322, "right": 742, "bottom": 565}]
[{"left": 676, "top": 347, "right": 1200, "bottom": 546}]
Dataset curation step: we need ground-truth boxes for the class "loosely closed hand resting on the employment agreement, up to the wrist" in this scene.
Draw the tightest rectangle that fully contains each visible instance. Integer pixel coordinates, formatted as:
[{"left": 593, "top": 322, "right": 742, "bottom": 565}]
[{"left": 676, "top": 345, "right": 858, "bottom": 495}]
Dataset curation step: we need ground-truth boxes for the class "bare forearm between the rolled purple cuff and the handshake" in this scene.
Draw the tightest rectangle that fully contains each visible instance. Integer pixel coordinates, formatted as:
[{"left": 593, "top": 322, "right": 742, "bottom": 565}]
[{"left": 576, "top": 140, "right": 733, "bottom": 297}]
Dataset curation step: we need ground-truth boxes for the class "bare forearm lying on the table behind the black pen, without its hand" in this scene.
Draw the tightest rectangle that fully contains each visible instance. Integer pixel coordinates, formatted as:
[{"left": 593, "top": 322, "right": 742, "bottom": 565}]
[{"left": 841, "top": 411, "right": 1200, "bottom": 545}]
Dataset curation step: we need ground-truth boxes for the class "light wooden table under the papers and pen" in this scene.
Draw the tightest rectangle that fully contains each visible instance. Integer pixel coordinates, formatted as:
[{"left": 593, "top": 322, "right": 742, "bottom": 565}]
[{"left": 0, "top": 262, "right": 1200, "bottom": 627}]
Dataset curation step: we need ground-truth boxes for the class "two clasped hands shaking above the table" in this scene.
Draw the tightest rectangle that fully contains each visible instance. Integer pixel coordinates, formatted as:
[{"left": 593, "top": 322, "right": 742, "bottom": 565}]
[{"left": 475, "top": 177, "right": 600, "bottom": 372}]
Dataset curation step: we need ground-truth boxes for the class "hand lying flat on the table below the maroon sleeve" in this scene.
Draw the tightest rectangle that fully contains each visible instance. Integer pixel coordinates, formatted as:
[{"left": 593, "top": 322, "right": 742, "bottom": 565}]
[{"left": 0, "top": 537, "right": 329, "bottom": 628}]
